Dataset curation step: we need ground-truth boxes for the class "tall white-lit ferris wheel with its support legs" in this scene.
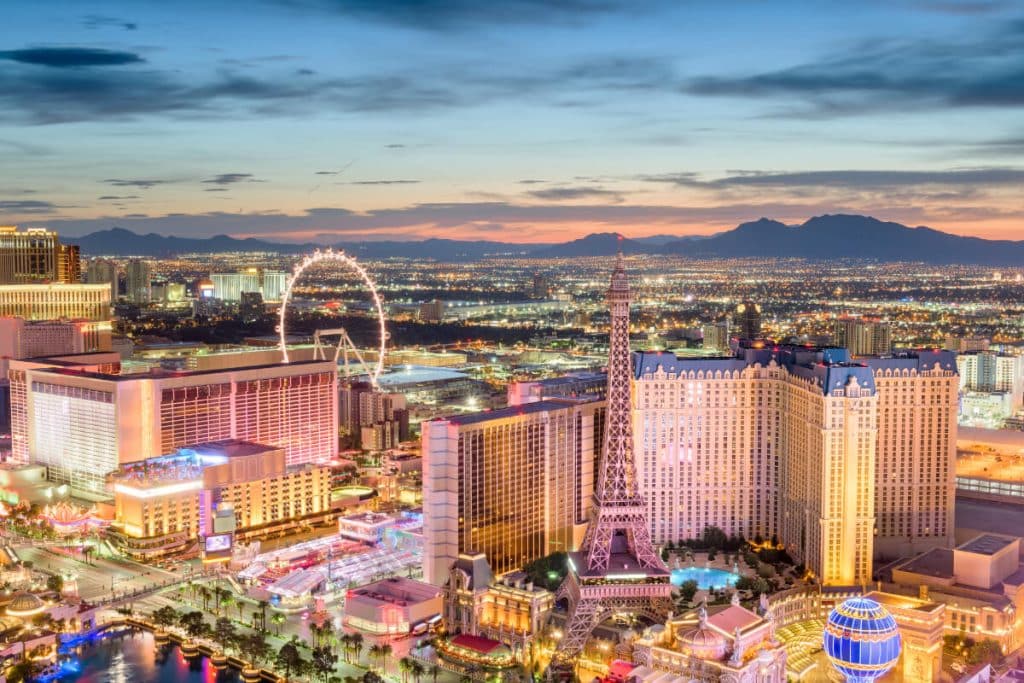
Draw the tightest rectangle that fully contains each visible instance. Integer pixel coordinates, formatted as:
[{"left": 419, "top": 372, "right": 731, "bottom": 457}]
[{"left": 278, "top": 249, "right": 388, "bottom": 387}]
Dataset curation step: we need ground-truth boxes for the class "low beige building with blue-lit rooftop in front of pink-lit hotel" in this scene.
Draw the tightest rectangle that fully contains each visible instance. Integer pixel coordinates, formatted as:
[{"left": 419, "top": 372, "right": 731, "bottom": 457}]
[{"left": 109, "top": 439, "right": 331, "bottom": 556}]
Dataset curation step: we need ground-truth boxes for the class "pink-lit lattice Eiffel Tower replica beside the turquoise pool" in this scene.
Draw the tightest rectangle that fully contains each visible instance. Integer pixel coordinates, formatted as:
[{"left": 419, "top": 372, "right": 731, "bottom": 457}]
[{"left": 549, "top": 252, "right": 672, "bottom": 679}]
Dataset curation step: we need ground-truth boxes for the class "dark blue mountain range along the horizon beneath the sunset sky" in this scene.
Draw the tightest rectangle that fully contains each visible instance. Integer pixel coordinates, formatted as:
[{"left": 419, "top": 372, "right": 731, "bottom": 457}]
[{"left": 76, "top": 214, "right": 1024, "bottom": 266}]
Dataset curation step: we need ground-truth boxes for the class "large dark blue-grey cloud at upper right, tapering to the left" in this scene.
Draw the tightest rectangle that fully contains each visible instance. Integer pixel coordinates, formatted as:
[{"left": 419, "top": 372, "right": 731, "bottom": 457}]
[{"left": 682, "top": 22, "right": 1024, "bottom": 118}]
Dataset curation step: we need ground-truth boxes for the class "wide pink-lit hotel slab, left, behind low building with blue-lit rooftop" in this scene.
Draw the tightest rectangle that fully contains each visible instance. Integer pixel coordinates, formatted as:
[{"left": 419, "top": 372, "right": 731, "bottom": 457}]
[{"left": 9, "top": 358, "right": 338, "bottom": 493}]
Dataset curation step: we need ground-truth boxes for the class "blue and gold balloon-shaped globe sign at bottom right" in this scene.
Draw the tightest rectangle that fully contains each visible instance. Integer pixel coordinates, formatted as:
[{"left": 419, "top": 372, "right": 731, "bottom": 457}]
[{"left": 822, "top": 597, "right": 902, "bottom": 683}]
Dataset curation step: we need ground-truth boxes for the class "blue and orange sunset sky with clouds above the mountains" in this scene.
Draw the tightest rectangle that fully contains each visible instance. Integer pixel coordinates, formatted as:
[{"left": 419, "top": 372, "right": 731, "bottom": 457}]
[{"left": 0, "top": 0, "right": 1024, "bottom": 244}]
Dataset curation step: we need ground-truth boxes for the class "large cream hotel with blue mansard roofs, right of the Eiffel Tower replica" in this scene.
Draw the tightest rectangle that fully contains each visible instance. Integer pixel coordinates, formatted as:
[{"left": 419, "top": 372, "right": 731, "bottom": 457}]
[{"left": 634, "top": 346, "right": 957, "bottom": 585}]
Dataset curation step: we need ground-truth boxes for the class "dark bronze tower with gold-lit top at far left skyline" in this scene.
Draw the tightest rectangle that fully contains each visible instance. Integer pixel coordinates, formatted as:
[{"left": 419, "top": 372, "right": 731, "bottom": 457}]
[{"left": 0, "top": 225, "right": 82, "bottom": 285}]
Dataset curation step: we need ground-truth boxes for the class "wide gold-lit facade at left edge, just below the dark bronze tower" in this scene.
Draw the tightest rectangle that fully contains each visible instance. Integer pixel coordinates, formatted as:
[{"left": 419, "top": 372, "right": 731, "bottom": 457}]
[{"left": 0, "top": 284, "right": 111, "bottom": 322}]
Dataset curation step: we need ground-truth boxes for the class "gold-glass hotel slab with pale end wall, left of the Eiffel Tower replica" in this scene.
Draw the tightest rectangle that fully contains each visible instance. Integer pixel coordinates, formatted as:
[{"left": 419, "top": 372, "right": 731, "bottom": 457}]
[{"left": 422, "top": 398, "right": 604, "bottom": 586}]
